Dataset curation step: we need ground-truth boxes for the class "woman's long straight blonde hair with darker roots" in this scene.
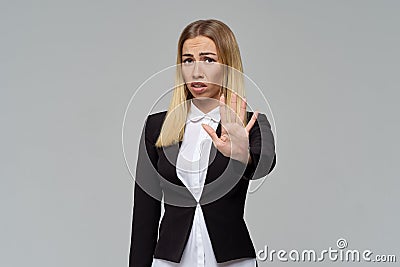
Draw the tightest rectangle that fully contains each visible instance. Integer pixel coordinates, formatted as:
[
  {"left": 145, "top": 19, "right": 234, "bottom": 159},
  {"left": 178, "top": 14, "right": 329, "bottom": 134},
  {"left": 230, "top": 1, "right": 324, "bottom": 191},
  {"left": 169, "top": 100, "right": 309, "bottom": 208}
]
[{"left": 155, "top": 19, "right": 247, "bottom": 147}]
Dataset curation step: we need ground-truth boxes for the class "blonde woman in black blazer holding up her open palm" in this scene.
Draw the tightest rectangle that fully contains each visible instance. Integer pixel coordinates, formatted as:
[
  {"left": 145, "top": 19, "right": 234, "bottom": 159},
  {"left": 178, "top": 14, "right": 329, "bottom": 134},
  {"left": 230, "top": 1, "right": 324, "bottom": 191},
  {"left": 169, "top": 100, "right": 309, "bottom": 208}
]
[{"left": 129, "top": 19, "right": 276, "bottom": 267}]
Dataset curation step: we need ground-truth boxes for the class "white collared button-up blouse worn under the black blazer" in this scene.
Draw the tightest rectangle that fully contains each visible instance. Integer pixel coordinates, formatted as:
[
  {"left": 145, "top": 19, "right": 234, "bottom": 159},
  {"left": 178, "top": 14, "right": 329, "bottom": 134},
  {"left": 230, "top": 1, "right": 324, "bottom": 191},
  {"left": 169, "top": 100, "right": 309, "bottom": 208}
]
[{"left": 152, "top": 101, "right": 256, "bottom": 267}]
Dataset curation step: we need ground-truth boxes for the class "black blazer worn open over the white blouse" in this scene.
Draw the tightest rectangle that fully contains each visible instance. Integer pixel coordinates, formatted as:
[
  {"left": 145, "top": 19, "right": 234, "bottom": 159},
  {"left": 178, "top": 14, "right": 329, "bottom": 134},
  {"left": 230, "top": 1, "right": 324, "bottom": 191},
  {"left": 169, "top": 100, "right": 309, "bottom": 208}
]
[{"left": 129, "top": 111, "right": 276, "bottom": 267}]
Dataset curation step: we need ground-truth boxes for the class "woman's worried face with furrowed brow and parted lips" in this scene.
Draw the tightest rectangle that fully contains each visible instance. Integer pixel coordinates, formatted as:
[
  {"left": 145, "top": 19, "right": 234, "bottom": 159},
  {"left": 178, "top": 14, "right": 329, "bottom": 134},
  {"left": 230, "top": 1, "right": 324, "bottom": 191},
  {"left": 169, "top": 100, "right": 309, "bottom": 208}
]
[{"left": 182, "top": 36, "right": 223, "bottom": 100}]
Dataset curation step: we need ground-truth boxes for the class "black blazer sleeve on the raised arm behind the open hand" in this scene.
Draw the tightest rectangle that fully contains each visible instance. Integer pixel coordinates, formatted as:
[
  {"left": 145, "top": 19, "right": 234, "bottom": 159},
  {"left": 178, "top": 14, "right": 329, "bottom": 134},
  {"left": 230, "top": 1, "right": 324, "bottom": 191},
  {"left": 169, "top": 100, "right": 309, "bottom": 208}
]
[{"left": 231, "top": 112, "right": 276, "bottom": 180}]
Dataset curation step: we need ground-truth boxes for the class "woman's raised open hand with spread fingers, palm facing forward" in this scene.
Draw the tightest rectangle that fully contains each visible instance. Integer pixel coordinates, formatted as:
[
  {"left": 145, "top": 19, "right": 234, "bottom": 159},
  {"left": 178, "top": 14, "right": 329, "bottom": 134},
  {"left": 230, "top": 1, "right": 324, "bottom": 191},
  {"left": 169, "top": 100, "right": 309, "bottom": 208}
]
[{"left": 202, "top": 92, "right": 258, "bottom": 164}]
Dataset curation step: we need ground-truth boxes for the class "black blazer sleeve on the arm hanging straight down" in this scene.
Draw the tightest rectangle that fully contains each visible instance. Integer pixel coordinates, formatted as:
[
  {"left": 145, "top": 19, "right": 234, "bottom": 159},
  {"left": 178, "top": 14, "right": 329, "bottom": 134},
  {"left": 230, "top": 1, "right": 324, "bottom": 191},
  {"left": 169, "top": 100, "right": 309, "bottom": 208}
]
[{"left": 129, "top": 117, "right": 162, "bottom": 267}]
